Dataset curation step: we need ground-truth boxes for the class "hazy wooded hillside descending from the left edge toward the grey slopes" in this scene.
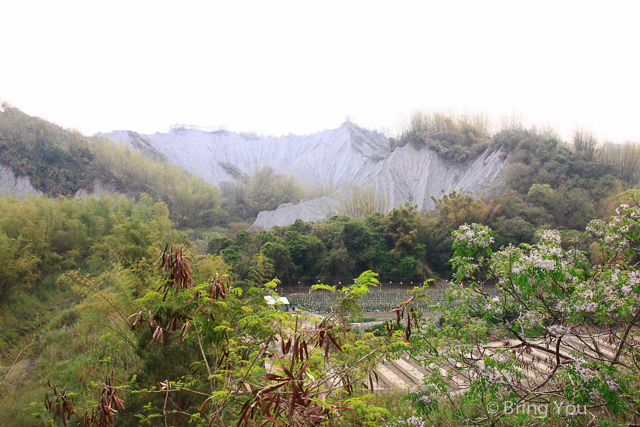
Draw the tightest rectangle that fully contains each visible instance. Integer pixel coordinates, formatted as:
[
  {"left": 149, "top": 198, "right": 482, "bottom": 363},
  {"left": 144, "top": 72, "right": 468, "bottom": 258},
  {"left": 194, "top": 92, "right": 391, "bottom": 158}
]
[{"left": 0, "top": 104, "right": 226, "bottom": 228}]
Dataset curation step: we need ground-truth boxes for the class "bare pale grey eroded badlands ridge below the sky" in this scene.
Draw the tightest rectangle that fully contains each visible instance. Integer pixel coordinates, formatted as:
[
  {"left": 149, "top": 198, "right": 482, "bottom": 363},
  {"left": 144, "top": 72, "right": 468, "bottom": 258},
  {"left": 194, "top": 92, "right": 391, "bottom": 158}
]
[{"left": 99, "top": 123, "right": 506, "bottom": 230}]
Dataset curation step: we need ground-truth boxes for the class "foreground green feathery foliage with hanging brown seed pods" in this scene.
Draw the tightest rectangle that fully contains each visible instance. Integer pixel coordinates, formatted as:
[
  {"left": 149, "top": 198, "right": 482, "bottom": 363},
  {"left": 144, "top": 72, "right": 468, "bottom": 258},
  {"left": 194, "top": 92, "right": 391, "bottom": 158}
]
[{"left": 38, "top": 260, "right": 417, "bottom": 426}]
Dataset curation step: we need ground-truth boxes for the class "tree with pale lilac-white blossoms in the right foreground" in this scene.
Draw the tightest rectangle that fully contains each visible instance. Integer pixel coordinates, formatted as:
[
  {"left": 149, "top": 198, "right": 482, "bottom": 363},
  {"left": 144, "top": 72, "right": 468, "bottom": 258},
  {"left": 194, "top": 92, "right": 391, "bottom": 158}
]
[{"left": 403, "top": 191, "right": 640, "bottom": 425}]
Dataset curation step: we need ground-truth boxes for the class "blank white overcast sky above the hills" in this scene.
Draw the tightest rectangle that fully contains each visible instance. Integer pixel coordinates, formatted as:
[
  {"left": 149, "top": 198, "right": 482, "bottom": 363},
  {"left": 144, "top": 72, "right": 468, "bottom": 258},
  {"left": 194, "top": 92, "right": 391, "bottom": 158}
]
[{"left": 0, "top": 0, "right": 640, "bottom": 141}]
